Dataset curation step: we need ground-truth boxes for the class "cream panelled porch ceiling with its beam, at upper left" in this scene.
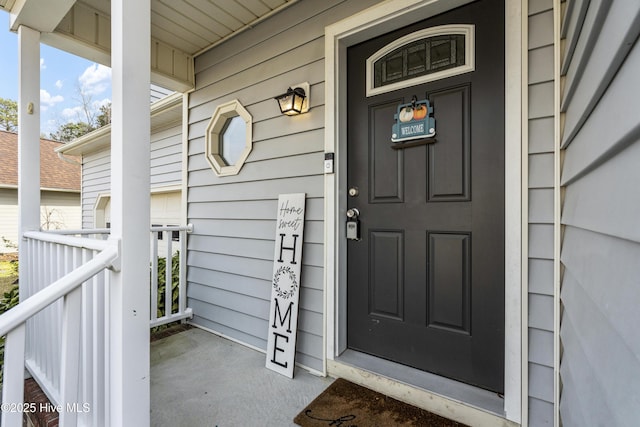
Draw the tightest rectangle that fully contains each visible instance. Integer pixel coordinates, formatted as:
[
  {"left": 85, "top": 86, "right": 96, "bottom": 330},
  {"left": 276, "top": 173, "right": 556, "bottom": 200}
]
[{"left": 0, "top": 0, "right": 298, "bottom": 91}]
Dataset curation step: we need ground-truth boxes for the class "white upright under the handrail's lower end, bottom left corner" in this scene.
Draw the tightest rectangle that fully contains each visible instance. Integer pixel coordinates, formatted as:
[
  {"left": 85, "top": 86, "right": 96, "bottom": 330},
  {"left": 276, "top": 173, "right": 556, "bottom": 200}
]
[{"left": 0, "top": 323, "right": 26, "bottom": 427}]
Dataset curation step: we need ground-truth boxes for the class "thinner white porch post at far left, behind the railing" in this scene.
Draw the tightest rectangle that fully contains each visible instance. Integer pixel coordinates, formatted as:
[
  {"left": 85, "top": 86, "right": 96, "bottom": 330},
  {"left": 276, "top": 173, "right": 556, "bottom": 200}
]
[{"left": 18, "top": 26, "right": 40, "bottom": 286}]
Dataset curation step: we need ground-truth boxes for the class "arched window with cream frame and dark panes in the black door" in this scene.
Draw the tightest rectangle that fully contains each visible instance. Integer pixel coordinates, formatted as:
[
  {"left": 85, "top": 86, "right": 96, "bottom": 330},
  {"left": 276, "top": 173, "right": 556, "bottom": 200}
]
[{"left": 367, "top": 24, "right": 475, "bottom": 96}]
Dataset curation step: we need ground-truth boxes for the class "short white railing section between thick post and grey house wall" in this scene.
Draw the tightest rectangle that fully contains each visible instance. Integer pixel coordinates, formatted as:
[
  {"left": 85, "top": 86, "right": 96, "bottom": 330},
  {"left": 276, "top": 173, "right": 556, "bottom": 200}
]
[{"left": 151, "top": 224, "right": 193, "bottom": 327}]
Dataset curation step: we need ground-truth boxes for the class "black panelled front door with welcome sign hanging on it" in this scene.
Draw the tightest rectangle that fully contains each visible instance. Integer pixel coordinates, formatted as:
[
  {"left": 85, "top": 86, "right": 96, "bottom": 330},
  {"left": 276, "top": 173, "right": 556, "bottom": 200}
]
[{"left": 345, "top": 0, "right": 504, "bottom": 392}]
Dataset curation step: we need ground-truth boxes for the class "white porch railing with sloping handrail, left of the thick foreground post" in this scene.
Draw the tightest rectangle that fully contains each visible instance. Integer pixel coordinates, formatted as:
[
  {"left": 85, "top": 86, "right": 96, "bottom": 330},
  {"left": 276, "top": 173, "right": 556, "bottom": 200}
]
[{"left": 0, "top": 232, "right": 120, "bottom": 427}]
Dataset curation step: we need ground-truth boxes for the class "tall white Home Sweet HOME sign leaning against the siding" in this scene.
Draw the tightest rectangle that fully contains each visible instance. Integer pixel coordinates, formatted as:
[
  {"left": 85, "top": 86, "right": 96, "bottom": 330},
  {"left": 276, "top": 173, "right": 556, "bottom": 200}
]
[{"left": 266, "top": 193, "right": 306, "bottom": 378}]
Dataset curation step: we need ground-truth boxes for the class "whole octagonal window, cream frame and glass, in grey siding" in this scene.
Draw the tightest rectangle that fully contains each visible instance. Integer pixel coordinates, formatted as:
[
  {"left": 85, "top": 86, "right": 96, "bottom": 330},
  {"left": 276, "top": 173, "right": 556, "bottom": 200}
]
[{"left": 205, "top": 100, "right": 252, "bottom": 176}]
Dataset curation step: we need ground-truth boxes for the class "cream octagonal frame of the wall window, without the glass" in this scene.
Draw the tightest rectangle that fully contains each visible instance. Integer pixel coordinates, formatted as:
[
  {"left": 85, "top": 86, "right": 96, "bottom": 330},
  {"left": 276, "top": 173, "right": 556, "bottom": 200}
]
[{"left": 205, "top": 99, "right": 253, "bottom": 176}]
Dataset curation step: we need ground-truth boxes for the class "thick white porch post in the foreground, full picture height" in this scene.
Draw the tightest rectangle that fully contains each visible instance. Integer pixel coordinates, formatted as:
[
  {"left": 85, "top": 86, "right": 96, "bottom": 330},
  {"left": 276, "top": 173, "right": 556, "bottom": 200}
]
[{"left": 107, "top": 0, "right": 151, "bottom": 427}]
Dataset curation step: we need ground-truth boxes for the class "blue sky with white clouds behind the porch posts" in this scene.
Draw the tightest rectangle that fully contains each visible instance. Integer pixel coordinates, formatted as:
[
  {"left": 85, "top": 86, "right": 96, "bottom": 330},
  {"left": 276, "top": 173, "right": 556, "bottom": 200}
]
[{"left": 0, "top": 12, "right": 111, "bottom": 136}]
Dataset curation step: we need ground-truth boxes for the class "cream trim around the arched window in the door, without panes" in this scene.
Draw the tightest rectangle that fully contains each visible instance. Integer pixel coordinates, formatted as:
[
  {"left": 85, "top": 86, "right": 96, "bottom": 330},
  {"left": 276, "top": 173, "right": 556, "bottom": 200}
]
[{"left": 366, "top": 24, "right": 476, "bottom": 97}]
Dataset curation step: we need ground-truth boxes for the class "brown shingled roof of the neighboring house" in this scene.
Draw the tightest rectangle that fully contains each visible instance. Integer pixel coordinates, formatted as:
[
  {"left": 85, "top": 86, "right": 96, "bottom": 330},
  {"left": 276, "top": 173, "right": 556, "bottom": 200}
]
[{"left": 0, "top": 130, "right": 81, "bottom": 192}]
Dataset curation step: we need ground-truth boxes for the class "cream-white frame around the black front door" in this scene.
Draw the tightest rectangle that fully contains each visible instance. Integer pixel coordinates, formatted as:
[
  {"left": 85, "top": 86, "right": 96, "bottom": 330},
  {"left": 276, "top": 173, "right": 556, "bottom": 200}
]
[{"left": 324, "top": 0, "right": 527, "bottom": 423}]
